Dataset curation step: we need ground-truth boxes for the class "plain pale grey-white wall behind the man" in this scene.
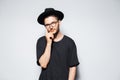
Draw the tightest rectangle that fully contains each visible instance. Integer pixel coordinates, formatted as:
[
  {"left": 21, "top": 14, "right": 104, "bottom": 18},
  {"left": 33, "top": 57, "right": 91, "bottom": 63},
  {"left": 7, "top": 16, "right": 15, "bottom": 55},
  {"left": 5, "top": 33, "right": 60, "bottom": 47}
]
[{"left": 0, "top": 0, "right": 120, "bottom": 80}]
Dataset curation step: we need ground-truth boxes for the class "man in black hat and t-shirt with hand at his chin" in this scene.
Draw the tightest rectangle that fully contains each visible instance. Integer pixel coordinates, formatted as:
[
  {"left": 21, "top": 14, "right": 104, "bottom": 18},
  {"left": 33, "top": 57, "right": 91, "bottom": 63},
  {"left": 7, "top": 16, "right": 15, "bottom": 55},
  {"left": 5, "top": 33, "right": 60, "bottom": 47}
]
[{"left": 36, "top": 8, "right": 79, "bottom": 80}]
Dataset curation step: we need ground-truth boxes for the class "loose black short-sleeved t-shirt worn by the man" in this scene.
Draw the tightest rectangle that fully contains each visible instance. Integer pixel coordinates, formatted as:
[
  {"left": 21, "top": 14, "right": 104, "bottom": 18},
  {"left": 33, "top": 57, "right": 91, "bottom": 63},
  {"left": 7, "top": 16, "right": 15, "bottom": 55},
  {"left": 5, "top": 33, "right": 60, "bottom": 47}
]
[{"left": 37, "top": 35, "right": 79, "bottom": 80}]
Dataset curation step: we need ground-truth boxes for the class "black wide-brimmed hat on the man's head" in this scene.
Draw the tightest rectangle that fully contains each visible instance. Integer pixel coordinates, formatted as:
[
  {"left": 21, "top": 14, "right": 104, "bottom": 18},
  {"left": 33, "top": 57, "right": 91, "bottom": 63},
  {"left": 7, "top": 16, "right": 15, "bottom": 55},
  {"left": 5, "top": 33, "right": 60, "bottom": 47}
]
[{"left": 37, "top": 8, "right": 64, "bottom": 25}]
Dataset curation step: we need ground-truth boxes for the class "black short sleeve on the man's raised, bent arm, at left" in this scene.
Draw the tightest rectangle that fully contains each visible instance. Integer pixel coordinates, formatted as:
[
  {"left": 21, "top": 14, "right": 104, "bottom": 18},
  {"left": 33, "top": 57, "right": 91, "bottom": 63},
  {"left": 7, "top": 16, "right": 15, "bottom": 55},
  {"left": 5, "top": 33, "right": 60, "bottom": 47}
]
[{"left": 36, "top": 37, "right": 46, "bottom": 65}]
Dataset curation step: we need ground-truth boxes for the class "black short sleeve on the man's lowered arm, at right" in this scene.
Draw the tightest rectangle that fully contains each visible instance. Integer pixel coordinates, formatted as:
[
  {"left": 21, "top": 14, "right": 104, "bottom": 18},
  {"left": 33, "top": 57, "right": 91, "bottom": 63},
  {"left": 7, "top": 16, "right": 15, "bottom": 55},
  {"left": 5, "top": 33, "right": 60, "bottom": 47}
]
[{"left": 69, "top": 41, "right": 79, "bottom": 67}]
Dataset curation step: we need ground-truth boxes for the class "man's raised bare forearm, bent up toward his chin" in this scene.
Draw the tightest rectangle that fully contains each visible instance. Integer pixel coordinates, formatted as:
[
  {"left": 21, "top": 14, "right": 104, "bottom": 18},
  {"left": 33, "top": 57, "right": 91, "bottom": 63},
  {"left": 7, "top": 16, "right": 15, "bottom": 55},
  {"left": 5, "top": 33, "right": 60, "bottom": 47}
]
[{"left": 39, "top": 44, "right": 51, "bottom": 68}]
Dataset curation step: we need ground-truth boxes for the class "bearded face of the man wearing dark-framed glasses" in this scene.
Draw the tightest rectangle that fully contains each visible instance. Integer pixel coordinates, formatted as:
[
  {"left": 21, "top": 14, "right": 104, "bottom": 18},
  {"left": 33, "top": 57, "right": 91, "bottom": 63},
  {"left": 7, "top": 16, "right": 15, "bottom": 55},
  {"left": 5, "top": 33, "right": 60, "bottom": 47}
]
[{"left": 44, "top": 16, "right": 60, "bottom": 34}]
